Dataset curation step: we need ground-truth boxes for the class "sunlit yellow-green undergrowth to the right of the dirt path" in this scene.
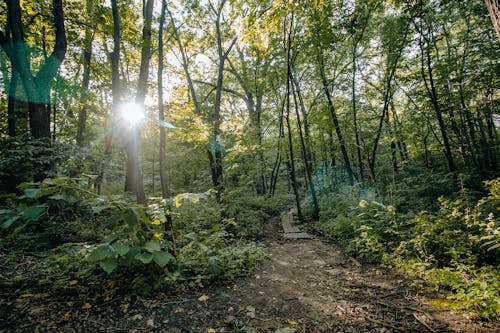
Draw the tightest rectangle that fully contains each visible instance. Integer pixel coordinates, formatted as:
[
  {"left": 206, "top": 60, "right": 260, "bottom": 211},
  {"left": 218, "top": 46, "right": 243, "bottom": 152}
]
[{"left": 311, "top": 175, "right": 500, "bottom": 320}]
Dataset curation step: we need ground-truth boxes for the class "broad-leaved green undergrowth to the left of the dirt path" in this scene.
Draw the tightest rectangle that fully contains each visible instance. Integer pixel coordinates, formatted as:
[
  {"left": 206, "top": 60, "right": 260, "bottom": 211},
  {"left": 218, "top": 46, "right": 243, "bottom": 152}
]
[{"left": 0, "top": 178, "right": 288, "bottom": 296}]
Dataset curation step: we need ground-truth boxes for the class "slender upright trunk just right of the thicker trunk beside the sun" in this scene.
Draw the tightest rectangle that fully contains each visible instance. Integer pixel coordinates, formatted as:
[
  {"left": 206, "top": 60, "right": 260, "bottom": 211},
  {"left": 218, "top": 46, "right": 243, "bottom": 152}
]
[{"left": 158, "top": 0, "right": 170, "bottom": 198}]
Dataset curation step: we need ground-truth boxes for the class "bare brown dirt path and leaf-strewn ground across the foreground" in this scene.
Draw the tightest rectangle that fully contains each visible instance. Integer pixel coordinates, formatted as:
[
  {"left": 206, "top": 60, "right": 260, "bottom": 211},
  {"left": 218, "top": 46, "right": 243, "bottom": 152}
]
[{"left": 0, "top": 214, "right": 500, "bottom": 333}]
